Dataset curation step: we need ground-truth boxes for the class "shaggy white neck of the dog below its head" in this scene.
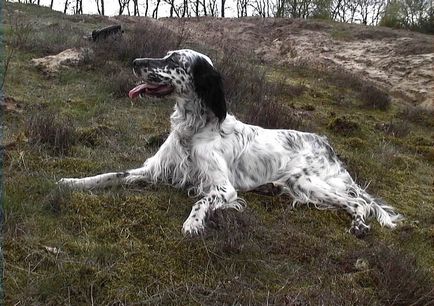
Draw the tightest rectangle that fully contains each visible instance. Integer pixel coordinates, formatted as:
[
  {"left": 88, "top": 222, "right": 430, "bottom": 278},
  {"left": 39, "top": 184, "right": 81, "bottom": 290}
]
[{"left": 170, "top": 98, "right": 219, "bottom": 142}]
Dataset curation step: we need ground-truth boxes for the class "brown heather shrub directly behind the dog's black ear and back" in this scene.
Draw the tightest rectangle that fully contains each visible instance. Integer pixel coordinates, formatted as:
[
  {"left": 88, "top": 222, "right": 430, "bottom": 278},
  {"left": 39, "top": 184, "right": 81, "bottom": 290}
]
[{"left": 216, "top": 49, "right": 306, "bottom": 129}]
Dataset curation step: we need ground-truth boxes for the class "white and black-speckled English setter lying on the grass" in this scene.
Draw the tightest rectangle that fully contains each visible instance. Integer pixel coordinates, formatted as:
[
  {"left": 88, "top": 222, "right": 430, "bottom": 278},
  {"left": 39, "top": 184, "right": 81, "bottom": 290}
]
[{"left": 59, "top": 49, "right": 400, "bottom": 236}]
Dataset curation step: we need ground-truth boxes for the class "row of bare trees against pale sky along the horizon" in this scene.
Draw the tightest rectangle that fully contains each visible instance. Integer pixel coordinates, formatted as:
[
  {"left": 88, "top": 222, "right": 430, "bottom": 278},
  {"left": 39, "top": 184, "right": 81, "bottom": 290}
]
[{"left": 10, "top": 0, "right": 434, "bottom": 35}]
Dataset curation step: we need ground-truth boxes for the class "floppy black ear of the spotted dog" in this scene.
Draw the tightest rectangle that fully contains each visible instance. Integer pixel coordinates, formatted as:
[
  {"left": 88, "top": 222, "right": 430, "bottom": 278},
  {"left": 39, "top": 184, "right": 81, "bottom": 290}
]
[{"left": 192, "top": 57, "right": 226, "bottom": 122}]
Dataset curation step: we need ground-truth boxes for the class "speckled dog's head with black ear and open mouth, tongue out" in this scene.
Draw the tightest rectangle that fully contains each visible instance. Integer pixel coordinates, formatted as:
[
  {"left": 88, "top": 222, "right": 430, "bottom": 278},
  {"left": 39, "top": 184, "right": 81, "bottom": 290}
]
[{"left": 129, "top": 49, "right": 226, "bottom": 121}]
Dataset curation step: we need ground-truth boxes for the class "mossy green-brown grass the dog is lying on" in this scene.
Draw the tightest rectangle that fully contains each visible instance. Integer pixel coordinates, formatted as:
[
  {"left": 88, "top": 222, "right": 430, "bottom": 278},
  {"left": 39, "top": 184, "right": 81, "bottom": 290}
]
[{"left": 3, "top": 3, "right": 434, "bottom": 305}]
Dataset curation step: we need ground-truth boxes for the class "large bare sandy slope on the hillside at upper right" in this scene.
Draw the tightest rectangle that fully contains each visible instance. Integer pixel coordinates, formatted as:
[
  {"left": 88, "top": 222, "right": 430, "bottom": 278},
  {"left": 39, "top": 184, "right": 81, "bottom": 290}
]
[{"left": 161, "top": 17, "right": 434, "bottom": 110}]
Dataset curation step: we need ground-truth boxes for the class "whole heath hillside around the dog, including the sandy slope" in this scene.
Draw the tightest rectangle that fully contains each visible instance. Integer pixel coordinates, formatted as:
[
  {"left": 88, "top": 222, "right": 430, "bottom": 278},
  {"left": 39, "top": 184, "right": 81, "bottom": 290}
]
[{"left": 2, "top": 3, "right": 434, "bottom": 305}]
